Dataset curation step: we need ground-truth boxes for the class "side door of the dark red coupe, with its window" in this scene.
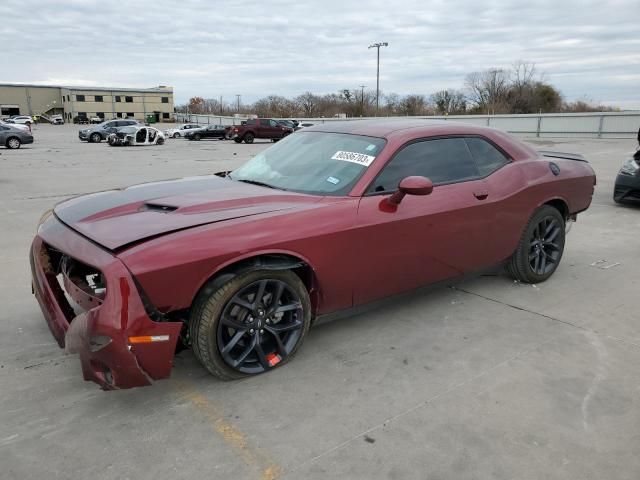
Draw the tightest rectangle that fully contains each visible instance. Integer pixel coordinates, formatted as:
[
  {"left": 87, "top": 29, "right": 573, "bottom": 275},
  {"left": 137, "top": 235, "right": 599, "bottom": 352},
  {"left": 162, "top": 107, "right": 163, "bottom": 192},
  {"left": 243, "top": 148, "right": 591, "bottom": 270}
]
[{"left": 354, "top": 137, "right": 489, "bottom": 304}]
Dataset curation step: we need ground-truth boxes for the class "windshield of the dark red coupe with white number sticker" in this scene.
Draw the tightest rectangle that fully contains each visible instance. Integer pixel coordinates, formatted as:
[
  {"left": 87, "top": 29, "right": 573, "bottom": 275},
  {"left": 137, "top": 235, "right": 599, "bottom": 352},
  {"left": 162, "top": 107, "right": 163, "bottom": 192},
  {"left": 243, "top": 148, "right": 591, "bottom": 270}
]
[{"left": 229, "top": 132, "right": 386, "bottom": 195}]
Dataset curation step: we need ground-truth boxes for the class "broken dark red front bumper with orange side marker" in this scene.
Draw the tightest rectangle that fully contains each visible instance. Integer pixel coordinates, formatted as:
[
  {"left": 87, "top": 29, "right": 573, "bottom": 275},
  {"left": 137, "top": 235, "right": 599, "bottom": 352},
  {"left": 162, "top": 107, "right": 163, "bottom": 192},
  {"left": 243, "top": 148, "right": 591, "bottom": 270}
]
[{"left": 30, "top": 215, "right": 182, "bottom": 390}]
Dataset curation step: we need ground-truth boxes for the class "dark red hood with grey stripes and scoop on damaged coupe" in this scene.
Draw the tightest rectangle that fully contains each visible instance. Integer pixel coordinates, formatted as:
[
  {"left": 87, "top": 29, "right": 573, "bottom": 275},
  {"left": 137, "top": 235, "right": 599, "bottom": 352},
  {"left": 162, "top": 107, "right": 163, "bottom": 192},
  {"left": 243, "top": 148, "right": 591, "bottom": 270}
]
[{"left": 54, "top": 175, "right": 322, "bottom": 250}]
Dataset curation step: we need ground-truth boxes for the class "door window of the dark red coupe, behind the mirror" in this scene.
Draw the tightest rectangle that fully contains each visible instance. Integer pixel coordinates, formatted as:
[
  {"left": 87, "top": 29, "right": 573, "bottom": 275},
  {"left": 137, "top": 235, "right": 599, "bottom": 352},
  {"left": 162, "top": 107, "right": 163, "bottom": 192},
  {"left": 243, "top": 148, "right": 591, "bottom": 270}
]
[{"left": 369, "top": 138, "right": 478, "bottom": 192}]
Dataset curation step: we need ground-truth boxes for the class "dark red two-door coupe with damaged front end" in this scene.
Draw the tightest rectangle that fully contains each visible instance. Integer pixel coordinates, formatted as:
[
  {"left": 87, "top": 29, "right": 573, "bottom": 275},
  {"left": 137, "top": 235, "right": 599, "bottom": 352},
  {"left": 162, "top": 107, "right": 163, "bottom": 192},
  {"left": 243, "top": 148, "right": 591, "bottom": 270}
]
[{"left": 31, "top": 120, "right": 595, "bottom": 389}]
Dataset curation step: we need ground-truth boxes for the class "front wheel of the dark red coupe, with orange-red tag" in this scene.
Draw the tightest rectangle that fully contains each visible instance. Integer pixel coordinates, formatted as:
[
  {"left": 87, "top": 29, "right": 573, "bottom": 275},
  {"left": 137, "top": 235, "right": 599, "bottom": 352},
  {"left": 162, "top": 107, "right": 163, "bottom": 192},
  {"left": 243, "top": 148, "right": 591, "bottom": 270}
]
[{"left": 189, "top": 270, "right": 311, "bottom": 380}]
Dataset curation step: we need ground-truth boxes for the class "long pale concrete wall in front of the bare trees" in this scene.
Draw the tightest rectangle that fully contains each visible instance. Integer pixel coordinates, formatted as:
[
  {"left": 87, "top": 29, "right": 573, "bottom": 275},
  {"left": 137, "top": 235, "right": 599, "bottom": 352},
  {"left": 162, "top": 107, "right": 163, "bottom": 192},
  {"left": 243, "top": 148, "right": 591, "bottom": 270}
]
[{"left": 176, "top": 111, "right": 640, "bottom": 138}]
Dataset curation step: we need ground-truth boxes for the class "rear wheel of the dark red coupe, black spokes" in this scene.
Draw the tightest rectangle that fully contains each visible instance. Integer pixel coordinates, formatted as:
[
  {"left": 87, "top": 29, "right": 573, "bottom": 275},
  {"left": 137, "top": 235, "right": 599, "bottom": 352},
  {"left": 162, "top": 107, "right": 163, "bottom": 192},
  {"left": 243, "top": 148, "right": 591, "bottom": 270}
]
[{"left": 507, "top": 205, "right": 565, "bottom": 283}]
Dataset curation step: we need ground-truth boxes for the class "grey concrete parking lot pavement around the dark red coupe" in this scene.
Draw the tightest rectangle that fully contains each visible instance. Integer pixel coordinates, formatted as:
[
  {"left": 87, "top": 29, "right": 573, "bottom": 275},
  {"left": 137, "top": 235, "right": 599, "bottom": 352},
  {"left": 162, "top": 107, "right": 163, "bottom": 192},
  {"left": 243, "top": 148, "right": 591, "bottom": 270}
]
[{"left": 0, "top": 125, "right": 640, "bottom": 480}]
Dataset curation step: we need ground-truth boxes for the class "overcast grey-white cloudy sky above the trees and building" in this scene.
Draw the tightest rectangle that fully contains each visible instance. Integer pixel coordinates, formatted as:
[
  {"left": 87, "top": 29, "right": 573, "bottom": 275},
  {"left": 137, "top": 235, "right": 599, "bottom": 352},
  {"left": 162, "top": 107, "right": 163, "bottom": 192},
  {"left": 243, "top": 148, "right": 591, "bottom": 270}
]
[{"left": 0, "top": 0, "right": 640, "bottom": 109}]
